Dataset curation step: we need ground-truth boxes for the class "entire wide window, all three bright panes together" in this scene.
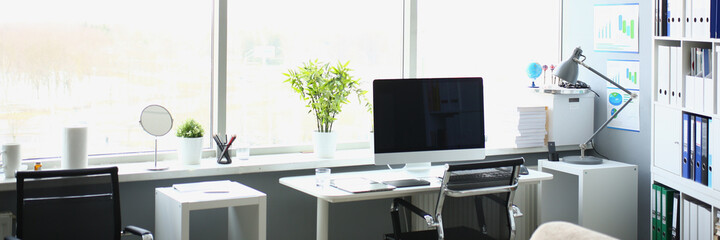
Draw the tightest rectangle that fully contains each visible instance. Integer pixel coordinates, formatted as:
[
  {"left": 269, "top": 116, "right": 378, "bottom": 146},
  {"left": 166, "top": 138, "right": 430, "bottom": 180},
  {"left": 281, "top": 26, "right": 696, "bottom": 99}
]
[{"left": 0, "top": 0, "right": 560, "bottom": 161}]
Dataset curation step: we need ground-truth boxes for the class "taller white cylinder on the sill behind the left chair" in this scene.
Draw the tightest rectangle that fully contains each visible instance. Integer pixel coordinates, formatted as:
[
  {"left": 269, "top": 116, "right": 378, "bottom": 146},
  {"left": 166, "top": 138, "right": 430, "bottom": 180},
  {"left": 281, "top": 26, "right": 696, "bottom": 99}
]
[{"left": 60, "top": 126, "right": 87, "bottom": 169}]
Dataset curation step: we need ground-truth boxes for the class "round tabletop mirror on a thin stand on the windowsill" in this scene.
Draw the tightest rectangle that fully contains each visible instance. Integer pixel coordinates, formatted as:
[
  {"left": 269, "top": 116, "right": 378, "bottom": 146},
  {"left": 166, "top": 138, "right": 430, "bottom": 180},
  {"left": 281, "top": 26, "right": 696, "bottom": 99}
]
[{"left": 140, "top": 104, "right": 173, "bottom": 171}]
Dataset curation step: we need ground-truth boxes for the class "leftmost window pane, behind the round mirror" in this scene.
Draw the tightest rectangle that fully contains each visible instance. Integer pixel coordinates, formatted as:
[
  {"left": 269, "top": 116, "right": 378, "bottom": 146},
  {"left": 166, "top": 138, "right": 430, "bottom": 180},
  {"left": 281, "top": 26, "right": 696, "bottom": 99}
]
[{"left": 0, "top": 0, "right": 213, "bottom": 158}]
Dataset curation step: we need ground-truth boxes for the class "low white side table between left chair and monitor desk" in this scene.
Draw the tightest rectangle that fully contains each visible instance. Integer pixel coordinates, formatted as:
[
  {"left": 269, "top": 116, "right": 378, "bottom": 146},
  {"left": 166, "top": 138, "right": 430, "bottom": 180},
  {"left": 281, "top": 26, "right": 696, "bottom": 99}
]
[{"left": 155, "top": 181, "right": 267, "bottom": 240}]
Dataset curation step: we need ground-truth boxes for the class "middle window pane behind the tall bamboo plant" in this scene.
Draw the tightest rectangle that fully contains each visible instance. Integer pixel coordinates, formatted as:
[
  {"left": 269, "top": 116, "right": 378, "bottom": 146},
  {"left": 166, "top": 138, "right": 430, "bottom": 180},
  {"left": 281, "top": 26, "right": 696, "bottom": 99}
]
[{"left": 227, "top": 0, "right": 403, "bottom": 146}]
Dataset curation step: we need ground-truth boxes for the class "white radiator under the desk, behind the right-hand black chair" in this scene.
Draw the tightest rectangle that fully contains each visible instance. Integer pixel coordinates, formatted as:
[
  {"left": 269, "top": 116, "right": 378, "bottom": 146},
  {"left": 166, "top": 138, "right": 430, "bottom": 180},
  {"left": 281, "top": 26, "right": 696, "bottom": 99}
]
[{"left": 411, "top": 184, "right": 538, "bottom": 240}]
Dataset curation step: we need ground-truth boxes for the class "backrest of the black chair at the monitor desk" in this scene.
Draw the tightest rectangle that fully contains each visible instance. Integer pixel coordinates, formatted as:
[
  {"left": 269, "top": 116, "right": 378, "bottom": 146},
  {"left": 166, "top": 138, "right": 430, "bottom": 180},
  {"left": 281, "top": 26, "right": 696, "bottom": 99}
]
[{"left": 435, "top": 158, "right": 525, "bottom": 239}]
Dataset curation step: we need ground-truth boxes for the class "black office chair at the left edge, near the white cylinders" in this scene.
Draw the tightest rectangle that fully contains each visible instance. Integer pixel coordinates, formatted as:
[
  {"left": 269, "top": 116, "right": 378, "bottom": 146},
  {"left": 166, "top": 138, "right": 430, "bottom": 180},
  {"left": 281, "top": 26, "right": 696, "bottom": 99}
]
[{"left": 5, "top": 167, "right": 153, "bottom": 240}]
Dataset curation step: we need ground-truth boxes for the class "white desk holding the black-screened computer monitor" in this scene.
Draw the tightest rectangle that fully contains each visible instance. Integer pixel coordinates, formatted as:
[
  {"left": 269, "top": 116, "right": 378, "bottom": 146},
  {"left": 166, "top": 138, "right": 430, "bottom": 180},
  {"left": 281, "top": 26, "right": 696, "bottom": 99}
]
[{"left": 280, "top": 166, "right": 553, "bottom": 240}]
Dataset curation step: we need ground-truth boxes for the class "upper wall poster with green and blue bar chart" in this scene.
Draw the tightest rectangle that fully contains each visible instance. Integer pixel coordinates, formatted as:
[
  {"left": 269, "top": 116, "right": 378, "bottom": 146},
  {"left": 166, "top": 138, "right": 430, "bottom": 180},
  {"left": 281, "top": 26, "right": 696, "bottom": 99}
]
[{"left": 594, "top": 3, "right": 640, "bottom": 53}]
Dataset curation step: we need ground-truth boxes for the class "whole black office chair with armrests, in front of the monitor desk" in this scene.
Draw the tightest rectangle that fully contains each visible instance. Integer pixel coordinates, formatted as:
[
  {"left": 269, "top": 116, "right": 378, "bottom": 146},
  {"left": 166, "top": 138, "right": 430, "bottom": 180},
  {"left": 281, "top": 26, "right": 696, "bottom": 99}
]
[{"left": 385, "top": 158, "right": 525, "bottom": 240}]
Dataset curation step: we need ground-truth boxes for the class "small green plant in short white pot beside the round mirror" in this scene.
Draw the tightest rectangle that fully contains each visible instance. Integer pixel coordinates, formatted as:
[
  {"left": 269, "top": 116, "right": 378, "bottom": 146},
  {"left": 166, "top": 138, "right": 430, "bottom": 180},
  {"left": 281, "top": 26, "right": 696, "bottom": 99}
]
[{"left": 175, "top": 118, "right": 205, "bottom": 165}]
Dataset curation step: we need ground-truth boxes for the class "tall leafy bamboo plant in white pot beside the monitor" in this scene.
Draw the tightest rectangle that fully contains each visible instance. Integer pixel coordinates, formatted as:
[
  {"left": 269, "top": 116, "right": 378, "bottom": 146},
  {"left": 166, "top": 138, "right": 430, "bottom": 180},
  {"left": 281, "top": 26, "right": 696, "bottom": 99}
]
[{"left": 284, "top": 60, "right": 369, "bottom": 158}]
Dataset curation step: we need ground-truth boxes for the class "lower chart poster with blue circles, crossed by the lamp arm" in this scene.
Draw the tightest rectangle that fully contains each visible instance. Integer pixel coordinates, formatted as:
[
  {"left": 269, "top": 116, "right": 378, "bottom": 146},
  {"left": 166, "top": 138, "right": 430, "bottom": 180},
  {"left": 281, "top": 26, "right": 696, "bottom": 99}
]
[{"left": 606, "top": 59, "right": 640, "bottom": 132}]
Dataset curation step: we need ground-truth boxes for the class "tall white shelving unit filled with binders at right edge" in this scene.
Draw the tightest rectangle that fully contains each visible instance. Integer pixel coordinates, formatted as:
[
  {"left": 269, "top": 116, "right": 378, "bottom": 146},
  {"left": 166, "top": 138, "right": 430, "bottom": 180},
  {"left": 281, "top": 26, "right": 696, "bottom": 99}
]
[{"left": 648, "top": 0, "right": 720, "bottom": 239}]
